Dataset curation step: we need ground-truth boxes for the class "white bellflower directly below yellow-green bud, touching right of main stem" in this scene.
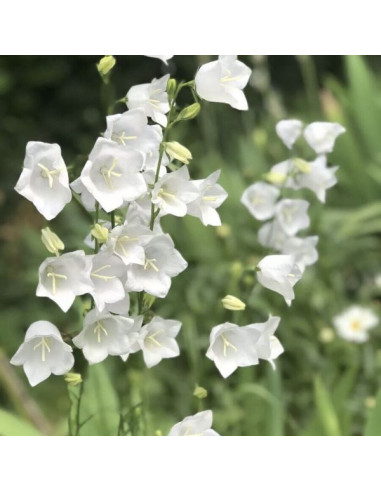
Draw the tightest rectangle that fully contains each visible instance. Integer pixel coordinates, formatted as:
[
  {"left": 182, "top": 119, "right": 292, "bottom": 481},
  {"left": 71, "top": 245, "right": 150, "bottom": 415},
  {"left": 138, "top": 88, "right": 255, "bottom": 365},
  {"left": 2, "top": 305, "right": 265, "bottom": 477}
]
[{"left": 151, "top": 166, "right": 199, "bottom": 217}]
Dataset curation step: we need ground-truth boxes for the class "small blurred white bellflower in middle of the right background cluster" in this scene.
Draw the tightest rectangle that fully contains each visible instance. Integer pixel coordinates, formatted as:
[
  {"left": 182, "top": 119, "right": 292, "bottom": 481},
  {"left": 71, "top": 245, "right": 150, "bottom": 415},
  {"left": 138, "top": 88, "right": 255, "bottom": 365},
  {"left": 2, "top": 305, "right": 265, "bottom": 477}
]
[{"left": 275, "top": 198, "right": 310, "bottom": 236}]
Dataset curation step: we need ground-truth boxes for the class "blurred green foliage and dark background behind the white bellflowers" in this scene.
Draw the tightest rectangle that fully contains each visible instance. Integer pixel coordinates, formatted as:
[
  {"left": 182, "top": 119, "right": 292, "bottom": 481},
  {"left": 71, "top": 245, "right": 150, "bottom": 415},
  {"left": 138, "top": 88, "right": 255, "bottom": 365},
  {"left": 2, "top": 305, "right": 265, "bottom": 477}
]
[{"left": 0, "top": 56, "right": 381, "bottom": 435}]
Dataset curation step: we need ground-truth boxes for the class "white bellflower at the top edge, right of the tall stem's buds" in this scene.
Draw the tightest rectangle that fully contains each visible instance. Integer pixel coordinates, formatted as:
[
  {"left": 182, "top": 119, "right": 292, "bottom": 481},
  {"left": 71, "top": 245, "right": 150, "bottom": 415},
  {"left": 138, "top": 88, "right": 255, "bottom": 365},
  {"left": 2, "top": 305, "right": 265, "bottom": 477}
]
[{"left": 195, "top": 55, "right": 251, "bottom": 110}]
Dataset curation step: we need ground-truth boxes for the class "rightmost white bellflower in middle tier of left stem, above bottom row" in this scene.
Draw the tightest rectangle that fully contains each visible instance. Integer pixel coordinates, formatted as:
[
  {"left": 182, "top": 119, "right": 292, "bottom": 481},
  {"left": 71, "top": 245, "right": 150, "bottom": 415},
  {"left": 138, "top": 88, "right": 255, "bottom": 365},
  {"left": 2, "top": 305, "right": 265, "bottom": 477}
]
[{"left": 126, "top": 234, "right": 188, "bottom": 297}]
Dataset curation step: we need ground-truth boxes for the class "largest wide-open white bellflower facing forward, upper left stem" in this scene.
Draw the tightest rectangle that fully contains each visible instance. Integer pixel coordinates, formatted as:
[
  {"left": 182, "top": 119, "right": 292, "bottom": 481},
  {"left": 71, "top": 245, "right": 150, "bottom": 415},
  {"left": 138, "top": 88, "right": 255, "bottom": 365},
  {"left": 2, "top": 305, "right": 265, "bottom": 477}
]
[{"left": 81, "top": 138, "right": 147, "bottom": 212}]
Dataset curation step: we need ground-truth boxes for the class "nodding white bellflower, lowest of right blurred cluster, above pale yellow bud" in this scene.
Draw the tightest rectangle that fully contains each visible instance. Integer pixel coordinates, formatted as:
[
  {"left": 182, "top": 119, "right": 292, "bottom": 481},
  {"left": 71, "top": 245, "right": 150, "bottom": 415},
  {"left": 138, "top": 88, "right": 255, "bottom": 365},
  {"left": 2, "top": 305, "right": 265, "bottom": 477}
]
[{"left": 257, "top": 255, "right": 302, "bottom": 306}]
